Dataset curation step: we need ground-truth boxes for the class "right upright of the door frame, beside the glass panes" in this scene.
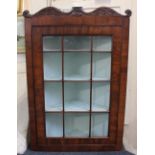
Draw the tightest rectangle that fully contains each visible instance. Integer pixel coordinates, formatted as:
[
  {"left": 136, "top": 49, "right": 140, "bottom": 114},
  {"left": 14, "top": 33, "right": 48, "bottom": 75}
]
[{"left": 109, "top": 29, "right": 121, "bottom": 143}]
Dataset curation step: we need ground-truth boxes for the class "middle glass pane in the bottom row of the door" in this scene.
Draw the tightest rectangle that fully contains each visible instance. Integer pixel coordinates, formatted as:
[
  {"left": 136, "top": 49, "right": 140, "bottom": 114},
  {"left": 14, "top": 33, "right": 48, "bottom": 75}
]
[{"left": 65, "top": 113, "right": 89, "bottom": 137}]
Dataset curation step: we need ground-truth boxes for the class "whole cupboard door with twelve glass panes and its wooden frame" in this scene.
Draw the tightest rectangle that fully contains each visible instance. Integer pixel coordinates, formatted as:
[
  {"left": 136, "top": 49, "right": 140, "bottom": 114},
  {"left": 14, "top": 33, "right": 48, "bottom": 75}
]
[{"left": 32, "top": 26, "right": 122, "bottom": 147}]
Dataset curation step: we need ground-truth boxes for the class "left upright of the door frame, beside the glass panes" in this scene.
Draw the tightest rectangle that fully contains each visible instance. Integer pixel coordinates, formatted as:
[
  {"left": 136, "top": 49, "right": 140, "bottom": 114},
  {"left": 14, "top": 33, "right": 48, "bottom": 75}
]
[{"left": 32, "top": 28, "right": 46, "bottom": 144}]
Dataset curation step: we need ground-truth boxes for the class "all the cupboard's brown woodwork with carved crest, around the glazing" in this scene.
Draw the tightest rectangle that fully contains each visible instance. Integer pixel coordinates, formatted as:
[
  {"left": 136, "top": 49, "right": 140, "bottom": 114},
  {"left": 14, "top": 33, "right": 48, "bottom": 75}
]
[{"left": 23, "top": 7, "right": 131, "bottom": 151}]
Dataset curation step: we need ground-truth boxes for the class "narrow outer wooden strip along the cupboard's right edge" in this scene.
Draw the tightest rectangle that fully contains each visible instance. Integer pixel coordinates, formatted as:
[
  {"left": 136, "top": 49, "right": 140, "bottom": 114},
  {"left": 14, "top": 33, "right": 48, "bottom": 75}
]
[{"left": 116, "top": 17, "right": 129, "bottom": 150}]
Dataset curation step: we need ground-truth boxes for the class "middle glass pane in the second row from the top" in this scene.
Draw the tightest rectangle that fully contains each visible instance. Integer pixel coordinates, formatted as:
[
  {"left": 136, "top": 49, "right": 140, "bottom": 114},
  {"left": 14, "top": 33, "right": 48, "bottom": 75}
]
[{"left": 64, "top": 52, "right": 90, "bottom": 80}]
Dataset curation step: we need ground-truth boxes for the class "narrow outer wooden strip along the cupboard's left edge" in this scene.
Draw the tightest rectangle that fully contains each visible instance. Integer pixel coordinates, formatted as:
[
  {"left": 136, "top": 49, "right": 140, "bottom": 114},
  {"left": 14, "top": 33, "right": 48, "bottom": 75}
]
[{"left": 25, "top": 18, "right": 37, "bottom": 146}]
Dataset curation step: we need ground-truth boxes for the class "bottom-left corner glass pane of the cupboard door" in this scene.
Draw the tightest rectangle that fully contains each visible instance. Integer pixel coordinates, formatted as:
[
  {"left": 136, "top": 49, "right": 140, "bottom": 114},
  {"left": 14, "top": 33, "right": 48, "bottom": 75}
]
[{"left": 46, "top": 113, "right": 63, "bottom": 137}]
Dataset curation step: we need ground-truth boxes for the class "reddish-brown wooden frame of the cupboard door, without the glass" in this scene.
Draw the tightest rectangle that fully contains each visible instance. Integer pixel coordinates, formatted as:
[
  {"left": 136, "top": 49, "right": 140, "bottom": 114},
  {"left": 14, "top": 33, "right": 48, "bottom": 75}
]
[{"left": 32, "top": 27, "right": 121, "bottom": 147}]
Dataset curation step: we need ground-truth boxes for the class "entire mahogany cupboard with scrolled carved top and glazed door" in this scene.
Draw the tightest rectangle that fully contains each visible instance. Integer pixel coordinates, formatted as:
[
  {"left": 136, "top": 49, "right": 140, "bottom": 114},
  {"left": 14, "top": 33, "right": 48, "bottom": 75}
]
[{"left": 23, "top": 7, "right": 131, "bottom": 151}]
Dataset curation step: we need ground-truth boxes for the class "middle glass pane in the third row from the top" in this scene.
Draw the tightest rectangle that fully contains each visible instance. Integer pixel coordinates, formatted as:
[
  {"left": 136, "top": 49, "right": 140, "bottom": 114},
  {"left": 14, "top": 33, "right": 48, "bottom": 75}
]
[{"left": 64, "top": 82, "right": 90, "bottom": 111}]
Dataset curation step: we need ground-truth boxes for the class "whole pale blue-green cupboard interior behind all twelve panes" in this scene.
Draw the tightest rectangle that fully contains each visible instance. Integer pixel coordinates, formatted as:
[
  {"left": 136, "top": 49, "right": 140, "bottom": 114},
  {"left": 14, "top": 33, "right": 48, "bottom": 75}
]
[{"left": 43, "top": 36, "right": 112, "bottom": 137}]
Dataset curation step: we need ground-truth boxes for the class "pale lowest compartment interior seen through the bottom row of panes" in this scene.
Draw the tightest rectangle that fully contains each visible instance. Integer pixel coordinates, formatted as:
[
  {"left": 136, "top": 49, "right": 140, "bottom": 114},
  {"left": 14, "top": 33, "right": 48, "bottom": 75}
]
[{"left": 46, "top": 113, "right": 109, "bottom": 137}]
